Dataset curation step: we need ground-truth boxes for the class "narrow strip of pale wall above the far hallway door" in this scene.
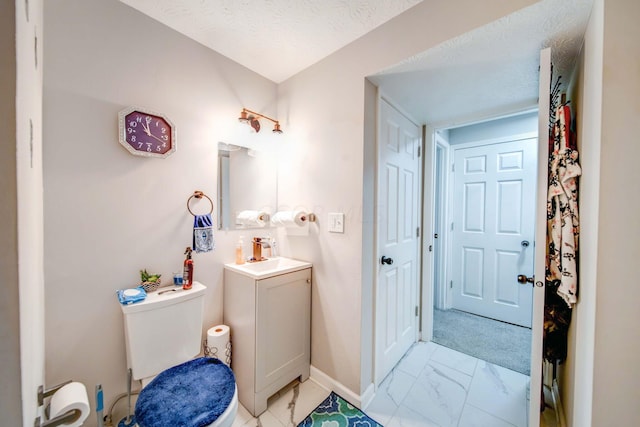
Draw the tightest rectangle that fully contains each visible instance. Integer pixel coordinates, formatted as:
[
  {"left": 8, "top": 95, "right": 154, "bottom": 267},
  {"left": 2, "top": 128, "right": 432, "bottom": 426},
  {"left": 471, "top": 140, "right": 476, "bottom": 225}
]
[{"left": 449, "top": 111, "right": 538, "bottom": 145}]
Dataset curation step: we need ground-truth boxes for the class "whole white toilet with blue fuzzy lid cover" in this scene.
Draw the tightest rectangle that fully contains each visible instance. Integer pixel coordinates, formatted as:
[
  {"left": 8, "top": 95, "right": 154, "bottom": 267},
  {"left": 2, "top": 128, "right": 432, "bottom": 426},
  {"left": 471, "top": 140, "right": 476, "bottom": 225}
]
[{"left": 121, "top": 282, "right": 238, "bottom": 427}]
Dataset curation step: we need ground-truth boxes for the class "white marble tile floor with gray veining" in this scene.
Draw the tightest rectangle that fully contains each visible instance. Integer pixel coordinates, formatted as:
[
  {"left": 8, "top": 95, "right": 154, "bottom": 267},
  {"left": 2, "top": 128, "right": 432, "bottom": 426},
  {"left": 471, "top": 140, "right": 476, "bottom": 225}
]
[{"left": 233, "top": 342, "right": 529, "bottom": 427}]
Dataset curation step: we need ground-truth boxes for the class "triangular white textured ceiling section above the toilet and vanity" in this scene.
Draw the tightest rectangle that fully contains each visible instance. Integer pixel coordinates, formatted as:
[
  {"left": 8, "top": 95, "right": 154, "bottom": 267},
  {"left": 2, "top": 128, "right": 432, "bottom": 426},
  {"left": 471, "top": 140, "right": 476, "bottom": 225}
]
[{"left": 120, "top": 0, "right": 422, "bottom": 83}]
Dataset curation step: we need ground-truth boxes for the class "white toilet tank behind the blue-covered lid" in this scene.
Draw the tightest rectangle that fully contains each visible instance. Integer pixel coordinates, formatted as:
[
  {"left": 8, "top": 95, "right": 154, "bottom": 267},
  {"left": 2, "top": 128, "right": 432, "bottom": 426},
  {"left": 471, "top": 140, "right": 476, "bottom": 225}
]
[{"left": 121, "top": 282, "right": 206, "bottom": 380}]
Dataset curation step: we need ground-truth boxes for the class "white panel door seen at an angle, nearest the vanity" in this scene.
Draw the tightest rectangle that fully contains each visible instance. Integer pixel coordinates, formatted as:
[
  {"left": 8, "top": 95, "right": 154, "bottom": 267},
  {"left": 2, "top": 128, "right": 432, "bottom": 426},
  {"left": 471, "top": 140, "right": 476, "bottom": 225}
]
[{"left": 375, "top": 99, "right": 421, "bottom": 384}]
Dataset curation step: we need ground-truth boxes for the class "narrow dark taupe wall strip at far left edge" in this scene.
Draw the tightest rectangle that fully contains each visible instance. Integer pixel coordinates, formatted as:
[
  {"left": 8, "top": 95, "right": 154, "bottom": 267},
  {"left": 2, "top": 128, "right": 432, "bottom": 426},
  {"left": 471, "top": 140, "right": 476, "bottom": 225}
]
[{"left": 0, "top": 1, "right": 22, "bottom": 426}]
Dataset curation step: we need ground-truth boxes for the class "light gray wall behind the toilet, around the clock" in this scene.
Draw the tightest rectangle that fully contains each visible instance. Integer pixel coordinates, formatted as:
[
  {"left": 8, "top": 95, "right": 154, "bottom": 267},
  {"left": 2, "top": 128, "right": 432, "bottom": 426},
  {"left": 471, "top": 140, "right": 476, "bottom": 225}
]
[{"left": 44, "top": 0, "right": 276, "bottom": 426}]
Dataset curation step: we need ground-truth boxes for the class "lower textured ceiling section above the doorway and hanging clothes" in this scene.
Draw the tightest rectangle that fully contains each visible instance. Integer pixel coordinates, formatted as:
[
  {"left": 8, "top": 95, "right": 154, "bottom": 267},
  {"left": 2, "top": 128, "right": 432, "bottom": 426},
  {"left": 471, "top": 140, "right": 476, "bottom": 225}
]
[{"left": 370, "top": 0, "right": 593, "bottom": 127}]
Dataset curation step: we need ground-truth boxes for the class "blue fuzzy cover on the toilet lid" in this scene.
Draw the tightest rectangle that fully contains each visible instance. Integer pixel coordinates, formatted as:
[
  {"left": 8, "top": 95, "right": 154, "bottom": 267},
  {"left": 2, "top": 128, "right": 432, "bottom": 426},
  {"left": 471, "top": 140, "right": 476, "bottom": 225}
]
[{"left": 135, "top": 357, "right": 235, "bottom": 427}]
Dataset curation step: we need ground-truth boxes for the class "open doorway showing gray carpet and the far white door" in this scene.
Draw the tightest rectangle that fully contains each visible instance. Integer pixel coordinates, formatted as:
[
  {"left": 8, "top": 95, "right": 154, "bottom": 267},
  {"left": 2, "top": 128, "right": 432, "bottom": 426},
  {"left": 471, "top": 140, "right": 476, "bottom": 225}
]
[{"left": 433, "top": 110, "right": 538, "bottom": 375}]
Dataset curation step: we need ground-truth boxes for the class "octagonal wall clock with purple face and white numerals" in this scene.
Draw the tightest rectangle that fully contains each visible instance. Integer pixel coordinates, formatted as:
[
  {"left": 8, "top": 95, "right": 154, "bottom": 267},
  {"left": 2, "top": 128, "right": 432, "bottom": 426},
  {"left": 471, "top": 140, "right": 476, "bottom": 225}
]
[{"left": 118, "top": 107, "right": 177, "bottom": 159}]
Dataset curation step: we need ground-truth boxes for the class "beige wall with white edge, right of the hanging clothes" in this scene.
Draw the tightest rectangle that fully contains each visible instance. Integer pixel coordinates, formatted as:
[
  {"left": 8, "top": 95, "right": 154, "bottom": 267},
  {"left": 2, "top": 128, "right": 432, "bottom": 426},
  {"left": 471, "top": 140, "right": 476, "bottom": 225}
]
[{"left": 561, "top": 0, "right": 640, "bottom": 427}]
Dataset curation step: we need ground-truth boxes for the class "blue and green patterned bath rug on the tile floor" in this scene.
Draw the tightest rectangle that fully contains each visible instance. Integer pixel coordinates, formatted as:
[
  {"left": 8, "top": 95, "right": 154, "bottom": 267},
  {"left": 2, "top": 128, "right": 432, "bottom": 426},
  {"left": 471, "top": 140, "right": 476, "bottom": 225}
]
[{"left": 298, "top": 392, "right": 383, "bottom": 427}]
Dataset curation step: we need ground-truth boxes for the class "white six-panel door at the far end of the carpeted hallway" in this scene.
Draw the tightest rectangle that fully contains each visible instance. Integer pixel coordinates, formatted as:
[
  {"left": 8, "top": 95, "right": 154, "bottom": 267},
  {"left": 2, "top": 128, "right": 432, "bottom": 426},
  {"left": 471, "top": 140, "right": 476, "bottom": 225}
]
[{"left": 452, "top": 138, "right": 537, "bottom": 327}]
